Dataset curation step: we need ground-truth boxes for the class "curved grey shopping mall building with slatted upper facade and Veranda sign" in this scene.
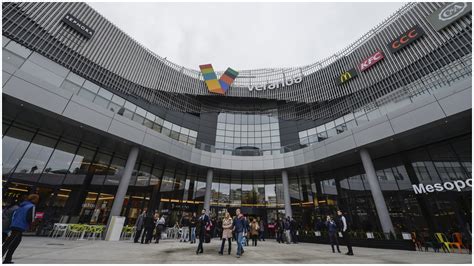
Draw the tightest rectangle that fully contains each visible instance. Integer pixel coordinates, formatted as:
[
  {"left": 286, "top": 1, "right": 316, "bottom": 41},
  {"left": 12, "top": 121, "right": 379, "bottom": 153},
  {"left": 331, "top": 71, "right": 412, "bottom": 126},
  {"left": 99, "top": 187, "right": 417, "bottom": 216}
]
[{"left": 2, "top": 2, "right": 472, "bottom": 239}]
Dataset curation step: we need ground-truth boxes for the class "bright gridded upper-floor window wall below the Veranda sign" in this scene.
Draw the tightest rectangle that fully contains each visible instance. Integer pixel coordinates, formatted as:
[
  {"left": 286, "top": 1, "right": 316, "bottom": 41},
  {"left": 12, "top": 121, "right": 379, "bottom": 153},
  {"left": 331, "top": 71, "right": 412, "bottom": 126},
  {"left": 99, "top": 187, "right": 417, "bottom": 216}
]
[{"left": 216, "top": 110, "right": 281, "bottom": 155}]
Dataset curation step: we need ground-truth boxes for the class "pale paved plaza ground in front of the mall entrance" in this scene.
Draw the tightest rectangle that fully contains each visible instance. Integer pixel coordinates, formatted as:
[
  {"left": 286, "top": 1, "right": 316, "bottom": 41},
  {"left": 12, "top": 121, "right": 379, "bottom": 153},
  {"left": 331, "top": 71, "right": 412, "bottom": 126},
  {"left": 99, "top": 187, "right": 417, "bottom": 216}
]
[{"left": 5, "top": 237, "right": 472, "bottom": 264}]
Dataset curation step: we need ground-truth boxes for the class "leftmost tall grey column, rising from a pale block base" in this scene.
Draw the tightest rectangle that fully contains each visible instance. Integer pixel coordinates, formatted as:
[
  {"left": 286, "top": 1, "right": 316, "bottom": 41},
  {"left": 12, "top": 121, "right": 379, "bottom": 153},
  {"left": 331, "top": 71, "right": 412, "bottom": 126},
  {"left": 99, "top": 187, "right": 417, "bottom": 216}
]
[{"left": 109, "top": 147, "right": 138, "bottom": 219}]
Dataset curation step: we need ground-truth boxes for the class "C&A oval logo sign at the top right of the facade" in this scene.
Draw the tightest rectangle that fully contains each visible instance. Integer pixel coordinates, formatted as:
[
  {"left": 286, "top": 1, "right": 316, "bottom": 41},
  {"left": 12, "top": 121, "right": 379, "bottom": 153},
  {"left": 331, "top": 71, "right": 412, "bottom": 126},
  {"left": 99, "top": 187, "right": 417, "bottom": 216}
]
[{"left": 428, "top": 2, "right": 472, "bottom": 31}]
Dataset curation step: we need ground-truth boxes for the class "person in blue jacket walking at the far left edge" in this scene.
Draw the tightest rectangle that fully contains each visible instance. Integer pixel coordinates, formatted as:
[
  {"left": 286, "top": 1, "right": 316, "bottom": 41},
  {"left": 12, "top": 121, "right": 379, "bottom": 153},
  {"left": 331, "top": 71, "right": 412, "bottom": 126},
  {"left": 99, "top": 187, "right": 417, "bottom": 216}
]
[{"left": 2, "top": 194, "right": 39, "bottom": 264}]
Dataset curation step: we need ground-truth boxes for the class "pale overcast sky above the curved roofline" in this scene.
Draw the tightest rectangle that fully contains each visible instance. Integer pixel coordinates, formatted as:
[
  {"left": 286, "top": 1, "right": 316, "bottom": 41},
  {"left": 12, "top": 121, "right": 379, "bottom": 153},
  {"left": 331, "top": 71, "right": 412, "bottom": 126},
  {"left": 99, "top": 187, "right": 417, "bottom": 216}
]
[{"left": 89, "top": 2, "right": 404, "bottom": 70}]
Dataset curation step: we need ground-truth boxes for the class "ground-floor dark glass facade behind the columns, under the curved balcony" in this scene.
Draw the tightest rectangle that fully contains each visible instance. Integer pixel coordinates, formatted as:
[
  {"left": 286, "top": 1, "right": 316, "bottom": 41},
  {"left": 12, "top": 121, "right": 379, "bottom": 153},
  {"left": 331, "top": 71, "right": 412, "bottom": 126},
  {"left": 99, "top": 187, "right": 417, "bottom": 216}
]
[{"left": 2, "top": 118, "right": 472, "bottom": 239}]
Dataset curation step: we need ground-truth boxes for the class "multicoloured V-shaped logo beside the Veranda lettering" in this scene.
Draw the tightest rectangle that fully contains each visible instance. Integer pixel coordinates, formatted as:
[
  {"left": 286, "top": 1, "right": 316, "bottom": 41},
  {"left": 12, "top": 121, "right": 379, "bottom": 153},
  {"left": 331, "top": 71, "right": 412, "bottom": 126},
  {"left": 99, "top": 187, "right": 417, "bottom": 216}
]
[{"left": 199, "top": 64, "right": 239, "bottom": 94}]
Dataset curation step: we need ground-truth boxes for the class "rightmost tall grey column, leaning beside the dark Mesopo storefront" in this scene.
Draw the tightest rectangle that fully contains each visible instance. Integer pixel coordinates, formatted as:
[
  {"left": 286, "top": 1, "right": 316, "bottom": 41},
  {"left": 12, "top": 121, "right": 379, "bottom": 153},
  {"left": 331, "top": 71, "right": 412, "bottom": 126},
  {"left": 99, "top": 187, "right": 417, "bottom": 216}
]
[{"left": 360, "top": 149, "right": 395, "bottom": 233}]
